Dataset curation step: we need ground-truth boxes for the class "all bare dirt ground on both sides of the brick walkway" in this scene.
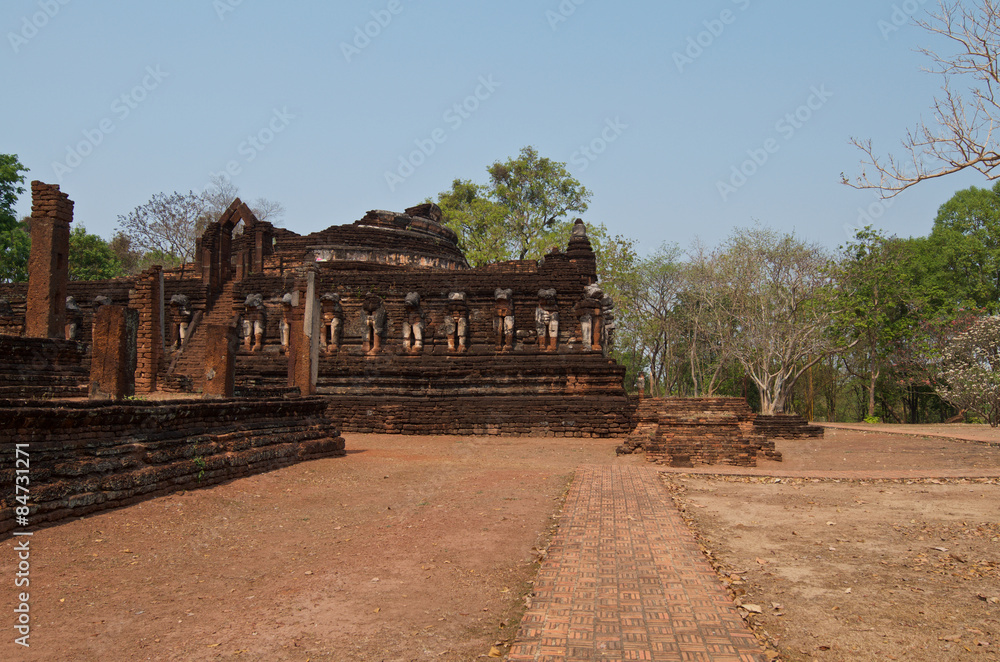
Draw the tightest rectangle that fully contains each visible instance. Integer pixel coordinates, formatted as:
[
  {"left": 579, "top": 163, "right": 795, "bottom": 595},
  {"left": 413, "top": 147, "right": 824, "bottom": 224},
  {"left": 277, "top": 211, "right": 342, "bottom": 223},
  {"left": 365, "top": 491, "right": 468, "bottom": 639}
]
[{"left": 0, "top": 430, "right": 1000, "bottom": 662}]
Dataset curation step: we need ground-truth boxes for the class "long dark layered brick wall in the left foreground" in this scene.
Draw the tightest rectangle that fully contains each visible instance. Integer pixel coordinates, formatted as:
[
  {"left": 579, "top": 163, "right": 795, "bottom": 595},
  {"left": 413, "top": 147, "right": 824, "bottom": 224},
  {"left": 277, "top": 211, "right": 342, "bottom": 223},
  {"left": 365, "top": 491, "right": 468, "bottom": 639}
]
[{"left": 0, "top": 398, "right": 345, "bottom": 536}]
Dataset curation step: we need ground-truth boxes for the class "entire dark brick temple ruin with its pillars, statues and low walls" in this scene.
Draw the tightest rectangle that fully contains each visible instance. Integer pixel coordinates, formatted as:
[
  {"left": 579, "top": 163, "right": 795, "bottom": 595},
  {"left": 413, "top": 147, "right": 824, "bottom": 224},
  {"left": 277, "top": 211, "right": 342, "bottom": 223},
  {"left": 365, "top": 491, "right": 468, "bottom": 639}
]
[{"left": 0, "top": 182, "right": 820, "bottom": 533}]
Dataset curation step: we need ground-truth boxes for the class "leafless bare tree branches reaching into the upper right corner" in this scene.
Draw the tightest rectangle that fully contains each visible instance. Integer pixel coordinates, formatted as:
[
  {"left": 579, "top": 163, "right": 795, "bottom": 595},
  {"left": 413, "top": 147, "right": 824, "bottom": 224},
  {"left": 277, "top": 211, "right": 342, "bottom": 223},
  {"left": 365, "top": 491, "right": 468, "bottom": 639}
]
[{"left": 841, "top": 0, "right": 1000, "bottom": 198}]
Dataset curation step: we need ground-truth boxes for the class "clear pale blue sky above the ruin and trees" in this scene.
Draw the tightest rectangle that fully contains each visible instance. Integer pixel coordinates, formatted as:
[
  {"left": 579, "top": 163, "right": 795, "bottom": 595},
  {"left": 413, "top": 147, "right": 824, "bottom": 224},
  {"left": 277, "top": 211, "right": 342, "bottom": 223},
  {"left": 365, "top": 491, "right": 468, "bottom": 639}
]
[{"left": 0, "top": 0, "right": 989, "bottom": 251}]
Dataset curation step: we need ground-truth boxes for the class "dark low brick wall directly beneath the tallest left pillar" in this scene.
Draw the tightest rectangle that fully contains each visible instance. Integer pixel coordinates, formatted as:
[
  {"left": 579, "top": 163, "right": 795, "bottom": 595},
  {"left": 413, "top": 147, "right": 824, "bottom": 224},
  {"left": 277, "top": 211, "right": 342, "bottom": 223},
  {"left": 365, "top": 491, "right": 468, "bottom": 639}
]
[{"left": 0, "top": 335, "right": 90, "bottom": 399}]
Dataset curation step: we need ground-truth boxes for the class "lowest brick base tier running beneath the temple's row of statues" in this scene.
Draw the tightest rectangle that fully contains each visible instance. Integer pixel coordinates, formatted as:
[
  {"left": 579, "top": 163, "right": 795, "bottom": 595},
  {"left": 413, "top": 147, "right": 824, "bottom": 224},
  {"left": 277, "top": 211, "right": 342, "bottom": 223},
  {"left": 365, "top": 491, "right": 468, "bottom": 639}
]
[{"left": 327, "top": 395, "right": 635, "bottom": 437}]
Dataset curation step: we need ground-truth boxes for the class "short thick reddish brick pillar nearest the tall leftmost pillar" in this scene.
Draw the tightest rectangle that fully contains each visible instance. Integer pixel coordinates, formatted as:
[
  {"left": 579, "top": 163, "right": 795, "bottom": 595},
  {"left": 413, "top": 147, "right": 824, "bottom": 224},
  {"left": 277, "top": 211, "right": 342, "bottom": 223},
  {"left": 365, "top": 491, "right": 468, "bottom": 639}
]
[{"left": 90, "top": 306, "right": 139, "bottom": 400}]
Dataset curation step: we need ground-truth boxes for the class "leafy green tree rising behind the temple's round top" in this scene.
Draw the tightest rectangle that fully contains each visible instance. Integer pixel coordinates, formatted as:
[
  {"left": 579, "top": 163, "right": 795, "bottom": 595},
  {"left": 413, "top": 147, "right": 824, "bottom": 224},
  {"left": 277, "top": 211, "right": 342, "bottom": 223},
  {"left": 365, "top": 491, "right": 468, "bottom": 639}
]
[{"left": 438, "top": 146, "right": 591, "bottom": 265}]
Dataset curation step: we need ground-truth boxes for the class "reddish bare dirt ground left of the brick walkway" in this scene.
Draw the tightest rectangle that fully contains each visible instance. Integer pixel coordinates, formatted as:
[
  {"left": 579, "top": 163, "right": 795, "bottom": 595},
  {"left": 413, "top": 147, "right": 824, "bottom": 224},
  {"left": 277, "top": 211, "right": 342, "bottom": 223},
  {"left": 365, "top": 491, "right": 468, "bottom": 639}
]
[{"left": 0, "top": 435, "right": 642, "bottom": 662}]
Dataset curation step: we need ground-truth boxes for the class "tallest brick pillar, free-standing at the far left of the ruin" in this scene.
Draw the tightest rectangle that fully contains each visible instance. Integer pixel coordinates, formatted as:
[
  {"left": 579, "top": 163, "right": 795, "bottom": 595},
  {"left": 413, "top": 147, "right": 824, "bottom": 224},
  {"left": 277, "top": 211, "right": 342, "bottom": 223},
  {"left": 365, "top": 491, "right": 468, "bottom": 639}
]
[{"left": 25, "top": 181, "right": 73, "bottom": 338}]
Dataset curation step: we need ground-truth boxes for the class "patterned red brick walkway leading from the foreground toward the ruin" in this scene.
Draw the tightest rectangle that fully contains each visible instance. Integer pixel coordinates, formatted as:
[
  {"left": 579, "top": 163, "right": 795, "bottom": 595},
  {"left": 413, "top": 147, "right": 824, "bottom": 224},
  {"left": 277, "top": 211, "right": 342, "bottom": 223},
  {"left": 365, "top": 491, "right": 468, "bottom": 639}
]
[{"left": 507, "top": 466, "right": 765, "bottom": 662}]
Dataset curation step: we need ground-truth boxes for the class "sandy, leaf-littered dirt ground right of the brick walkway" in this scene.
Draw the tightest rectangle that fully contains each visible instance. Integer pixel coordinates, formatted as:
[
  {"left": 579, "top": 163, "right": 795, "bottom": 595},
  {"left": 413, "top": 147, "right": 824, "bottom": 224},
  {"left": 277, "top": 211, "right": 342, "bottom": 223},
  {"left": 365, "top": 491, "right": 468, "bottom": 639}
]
[{"left": 666, "top": 430, "right": 1000, "bottom": 662}]
